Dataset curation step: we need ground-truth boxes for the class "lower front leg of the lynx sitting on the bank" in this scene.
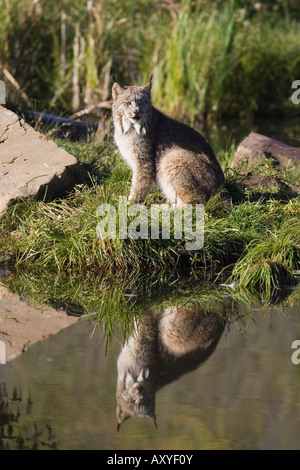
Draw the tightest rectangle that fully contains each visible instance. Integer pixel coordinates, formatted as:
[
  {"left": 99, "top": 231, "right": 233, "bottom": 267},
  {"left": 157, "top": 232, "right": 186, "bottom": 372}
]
[{"left": 128, "top": 164, "right": 155, "bottom": 203}]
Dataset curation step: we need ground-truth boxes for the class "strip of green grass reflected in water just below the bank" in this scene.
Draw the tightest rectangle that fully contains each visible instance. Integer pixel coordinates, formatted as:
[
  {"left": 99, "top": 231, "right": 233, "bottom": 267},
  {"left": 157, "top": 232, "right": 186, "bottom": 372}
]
[{"left": 2, "top": 264, "right": 300, "bottom": 347}]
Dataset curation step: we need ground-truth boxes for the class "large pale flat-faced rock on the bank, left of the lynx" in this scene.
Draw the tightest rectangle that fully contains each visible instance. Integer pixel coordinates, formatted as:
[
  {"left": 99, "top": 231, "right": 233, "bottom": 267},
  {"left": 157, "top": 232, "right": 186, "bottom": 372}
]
[{"left": 0, "top": 106, "right": 86, "bottom": 216}]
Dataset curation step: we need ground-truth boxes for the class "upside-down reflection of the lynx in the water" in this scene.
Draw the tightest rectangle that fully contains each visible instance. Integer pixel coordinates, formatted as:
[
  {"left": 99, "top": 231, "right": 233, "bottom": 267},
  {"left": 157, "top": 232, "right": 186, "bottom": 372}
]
[{"left": 116, "top": 306, "right": 225, "bottom": 429}]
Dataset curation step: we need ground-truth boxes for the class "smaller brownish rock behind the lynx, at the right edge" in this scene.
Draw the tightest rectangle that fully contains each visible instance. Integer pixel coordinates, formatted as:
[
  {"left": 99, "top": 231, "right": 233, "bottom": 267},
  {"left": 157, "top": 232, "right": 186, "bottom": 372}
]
[{"left": 232, "top": 132, "right": 300, "bottom": 171}]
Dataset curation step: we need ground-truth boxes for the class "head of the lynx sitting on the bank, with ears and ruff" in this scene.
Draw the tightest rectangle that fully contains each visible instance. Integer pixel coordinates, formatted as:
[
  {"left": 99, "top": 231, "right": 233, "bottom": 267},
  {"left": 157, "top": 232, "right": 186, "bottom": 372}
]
[{"left": 112, "top": 77, "right": 152, "bottom": 135}]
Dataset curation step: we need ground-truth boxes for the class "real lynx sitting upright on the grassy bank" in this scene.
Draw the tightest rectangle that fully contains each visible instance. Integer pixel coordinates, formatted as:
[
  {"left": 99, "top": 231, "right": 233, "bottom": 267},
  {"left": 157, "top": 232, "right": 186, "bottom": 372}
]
[{"left": 112, "top": 76, "right": 224, "bottom": 207}]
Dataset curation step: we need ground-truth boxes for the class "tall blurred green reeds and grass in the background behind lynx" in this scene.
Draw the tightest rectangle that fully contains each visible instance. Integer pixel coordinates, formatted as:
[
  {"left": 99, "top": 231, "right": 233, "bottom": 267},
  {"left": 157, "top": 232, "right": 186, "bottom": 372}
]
[{"left": 0, "top": 0, "right": 300, "bottom": 122}]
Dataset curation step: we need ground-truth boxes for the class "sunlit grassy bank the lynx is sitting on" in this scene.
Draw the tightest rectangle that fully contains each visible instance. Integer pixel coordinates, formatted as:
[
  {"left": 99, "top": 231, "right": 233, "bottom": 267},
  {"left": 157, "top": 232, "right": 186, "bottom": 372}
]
[{"left": 0, "top": 134, "right": 300, "bottom": 297}]
